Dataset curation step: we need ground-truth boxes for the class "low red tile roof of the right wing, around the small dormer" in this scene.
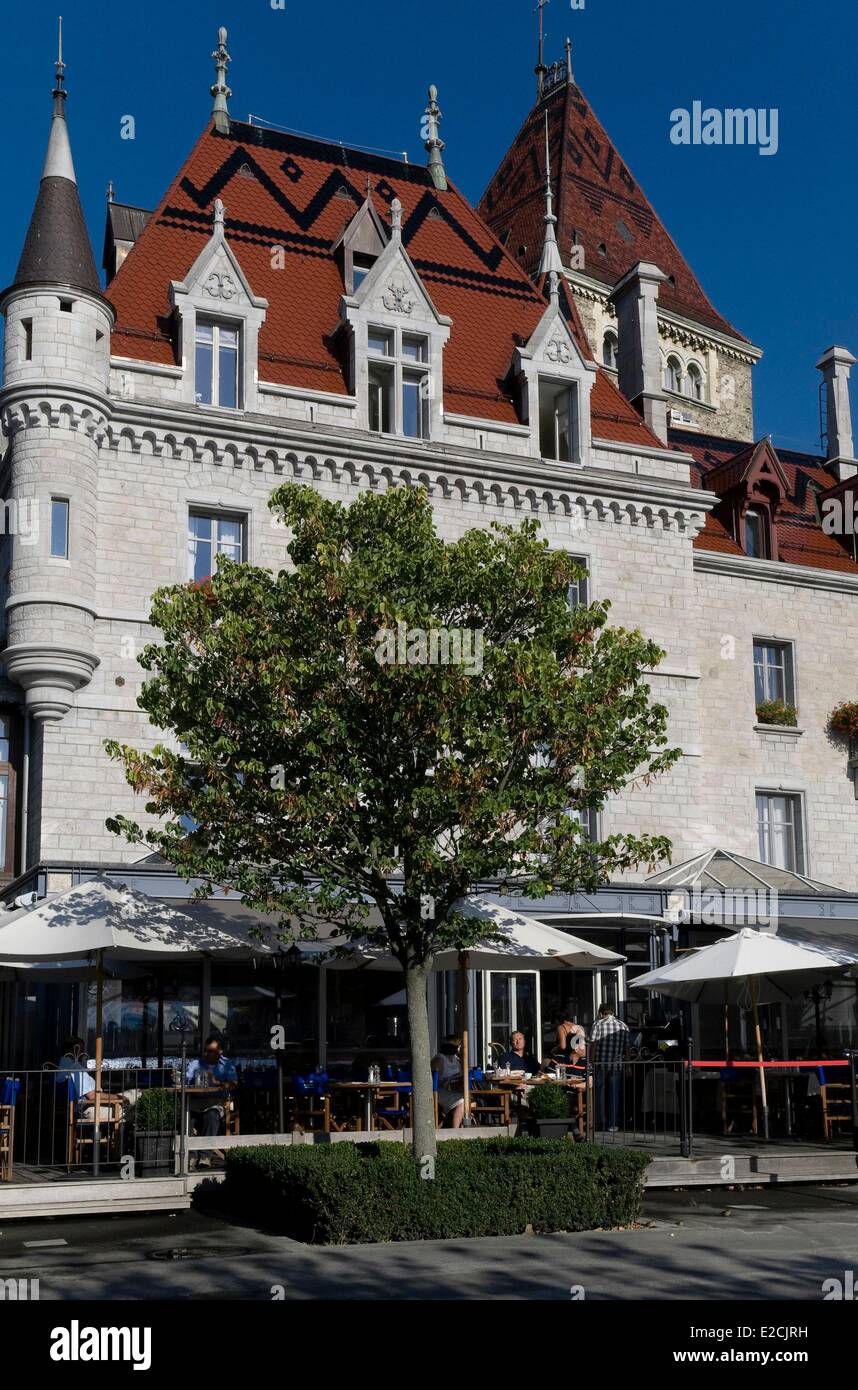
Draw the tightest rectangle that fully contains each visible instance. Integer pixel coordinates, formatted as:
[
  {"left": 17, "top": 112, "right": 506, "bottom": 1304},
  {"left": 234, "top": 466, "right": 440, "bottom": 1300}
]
[{"left": 669, "top": 430, "right": 858, "bottom": 574}]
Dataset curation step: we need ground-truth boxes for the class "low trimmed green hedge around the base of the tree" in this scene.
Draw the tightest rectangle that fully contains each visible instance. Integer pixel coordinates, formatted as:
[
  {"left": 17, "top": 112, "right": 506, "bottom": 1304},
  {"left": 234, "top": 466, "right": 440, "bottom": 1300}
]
[{"left": 216, "top": 1138, "right": 649, "bottom": 1245}]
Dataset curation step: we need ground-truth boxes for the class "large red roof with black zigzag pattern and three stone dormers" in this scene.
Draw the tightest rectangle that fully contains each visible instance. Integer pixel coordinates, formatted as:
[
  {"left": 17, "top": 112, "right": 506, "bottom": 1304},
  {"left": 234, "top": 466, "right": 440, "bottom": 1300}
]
[{"left": 107, "top": 122, "right": 659, "bottom": 446}]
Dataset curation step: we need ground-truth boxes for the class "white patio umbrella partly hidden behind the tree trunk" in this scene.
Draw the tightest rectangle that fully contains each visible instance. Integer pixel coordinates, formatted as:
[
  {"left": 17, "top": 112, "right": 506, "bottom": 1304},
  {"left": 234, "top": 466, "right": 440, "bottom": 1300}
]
[{"left": 331, "top": 897, "right": 624, "bottom": 1116}]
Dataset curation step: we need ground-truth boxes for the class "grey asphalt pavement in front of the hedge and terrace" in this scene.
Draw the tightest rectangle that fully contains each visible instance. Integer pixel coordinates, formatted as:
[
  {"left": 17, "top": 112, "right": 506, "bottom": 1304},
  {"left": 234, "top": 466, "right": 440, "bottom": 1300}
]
[{"left": 0, "top": 1184, "right": 858, "bottom": 1301}]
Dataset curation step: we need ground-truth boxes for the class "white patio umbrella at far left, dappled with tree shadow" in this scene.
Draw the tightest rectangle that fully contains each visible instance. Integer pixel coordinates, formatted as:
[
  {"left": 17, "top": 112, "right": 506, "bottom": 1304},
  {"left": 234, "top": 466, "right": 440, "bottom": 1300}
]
[{"left": 0, "top": 878, "right": 270, "bottom": 1165}]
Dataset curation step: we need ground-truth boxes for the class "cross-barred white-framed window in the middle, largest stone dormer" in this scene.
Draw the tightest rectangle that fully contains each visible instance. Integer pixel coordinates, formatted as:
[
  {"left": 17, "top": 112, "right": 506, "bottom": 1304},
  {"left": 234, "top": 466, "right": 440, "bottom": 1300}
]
[{"left": 367, "top": 327, "right": 431, "bottom": 439}]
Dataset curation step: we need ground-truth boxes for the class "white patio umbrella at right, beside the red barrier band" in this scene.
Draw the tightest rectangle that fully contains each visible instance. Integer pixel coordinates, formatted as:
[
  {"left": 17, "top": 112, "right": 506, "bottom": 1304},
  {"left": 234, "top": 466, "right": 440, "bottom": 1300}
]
[{"left": 631, "top": 927, "right": 858, "bottom": 1138}]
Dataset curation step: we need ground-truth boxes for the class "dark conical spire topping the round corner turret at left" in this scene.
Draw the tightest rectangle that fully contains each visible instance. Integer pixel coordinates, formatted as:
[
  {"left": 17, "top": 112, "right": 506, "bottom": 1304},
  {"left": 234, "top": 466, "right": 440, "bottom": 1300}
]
[{"left": 15, "top": 19, "right": 102, "bottom": 295}]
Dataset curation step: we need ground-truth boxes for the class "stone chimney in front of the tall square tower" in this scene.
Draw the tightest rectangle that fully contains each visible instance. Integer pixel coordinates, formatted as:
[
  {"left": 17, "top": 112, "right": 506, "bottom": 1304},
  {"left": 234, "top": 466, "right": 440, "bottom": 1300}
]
[{"left": 610, "top": 261, "right": 667, "bottom": 443}]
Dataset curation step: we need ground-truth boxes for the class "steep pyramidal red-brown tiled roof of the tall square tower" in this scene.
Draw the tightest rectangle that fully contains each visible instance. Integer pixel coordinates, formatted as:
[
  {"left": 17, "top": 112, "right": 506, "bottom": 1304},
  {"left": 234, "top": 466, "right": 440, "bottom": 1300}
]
[{"left": 477, "top": 82, "right": 747, "bottom": 342}]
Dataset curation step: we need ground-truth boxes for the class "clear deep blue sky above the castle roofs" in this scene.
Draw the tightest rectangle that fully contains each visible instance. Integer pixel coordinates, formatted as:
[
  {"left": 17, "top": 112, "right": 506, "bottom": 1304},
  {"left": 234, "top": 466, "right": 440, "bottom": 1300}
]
[{"left": 0, "top": 0, "right": 858, "bottom": 449}]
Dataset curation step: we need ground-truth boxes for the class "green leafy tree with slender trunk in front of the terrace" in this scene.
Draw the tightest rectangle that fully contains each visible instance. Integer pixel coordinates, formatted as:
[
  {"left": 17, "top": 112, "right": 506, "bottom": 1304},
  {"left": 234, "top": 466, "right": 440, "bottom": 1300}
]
[{"left": 106, "top": 484, "right": 679, "bottom": 1158}]
